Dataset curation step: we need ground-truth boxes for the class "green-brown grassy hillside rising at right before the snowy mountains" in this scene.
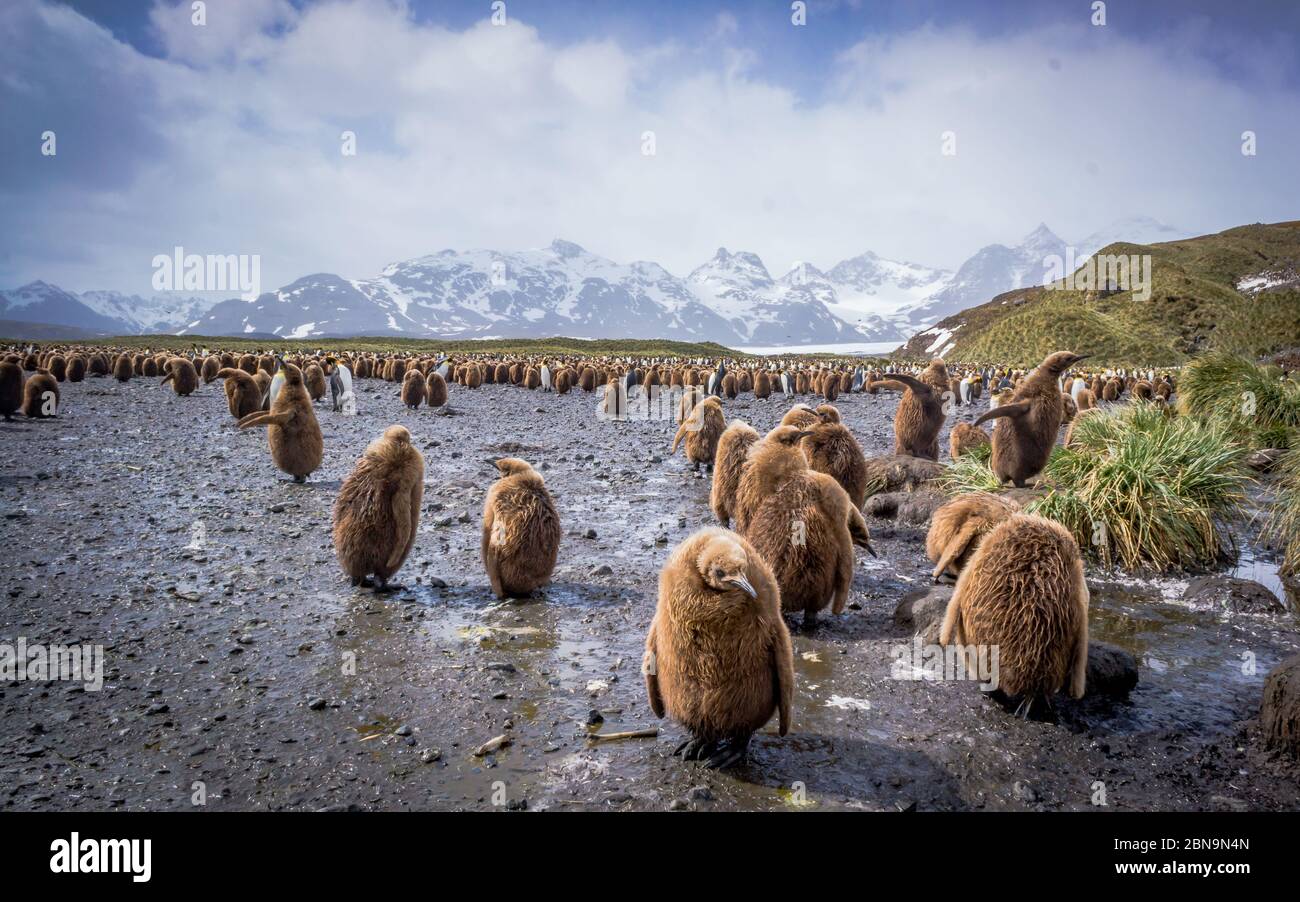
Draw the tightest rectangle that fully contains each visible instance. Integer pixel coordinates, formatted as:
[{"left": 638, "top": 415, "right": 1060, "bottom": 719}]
[{"left": 900, "top": 221, "right": 1300, "bottom": 367}]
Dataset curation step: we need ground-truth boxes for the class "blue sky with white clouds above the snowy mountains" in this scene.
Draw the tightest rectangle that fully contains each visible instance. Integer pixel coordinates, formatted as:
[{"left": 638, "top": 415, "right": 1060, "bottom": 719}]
[{"left": 0, "top": 0, "right": 1300, "bottom": 292}]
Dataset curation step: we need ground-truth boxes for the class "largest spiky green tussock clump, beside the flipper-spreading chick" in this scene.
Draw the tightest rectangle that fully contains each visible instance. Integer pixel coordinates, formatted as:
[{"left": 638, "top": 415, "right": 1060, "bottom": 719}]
[{"left": 1027, "top": 403, "right": 1249, "bottom": 572}]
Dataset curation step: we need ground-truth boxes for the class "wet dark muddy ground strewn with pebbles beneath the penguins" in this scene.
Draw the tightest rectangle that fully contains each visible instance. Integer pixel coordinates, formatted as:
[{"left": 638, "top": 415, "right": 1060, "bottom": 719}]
[{"left": 0, "top": 380, "right": 1300, "bottom": 810}]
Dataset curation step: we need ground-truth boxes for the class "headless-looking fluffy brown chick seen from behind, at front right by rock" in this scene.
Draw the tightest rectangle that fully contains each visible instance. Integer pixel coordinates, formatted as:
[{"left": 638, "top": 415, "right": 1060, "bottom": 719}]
[{"left": 939, "top": 513, "right": 1088, "bottom": 717}]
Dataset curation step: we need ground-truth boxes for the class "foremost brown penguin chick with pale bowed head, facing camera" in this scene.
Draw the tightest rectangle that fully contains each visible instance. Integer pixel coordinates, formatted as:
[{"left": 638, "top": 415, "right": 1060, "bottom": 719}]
[{"left": 641, "top": 528, "right": 794, "bottom": 767}]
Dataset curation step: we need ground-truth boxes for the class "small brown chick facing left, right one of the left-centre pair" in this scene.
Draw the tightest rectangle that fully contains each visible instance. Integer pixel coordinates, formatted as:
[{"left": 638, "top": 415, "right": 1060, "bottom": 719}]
[{"left": 481, "top": 457, "right": 560, "bottom": 598}]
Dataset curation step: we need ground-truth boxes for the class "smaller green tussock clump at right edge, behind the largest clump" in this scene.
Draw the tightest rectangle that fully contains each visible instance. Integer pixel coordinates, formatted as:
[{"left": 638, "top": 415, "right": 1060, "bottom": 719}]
[{"left": 1178, "top": 352, "right": 1300, "bottom": 448}]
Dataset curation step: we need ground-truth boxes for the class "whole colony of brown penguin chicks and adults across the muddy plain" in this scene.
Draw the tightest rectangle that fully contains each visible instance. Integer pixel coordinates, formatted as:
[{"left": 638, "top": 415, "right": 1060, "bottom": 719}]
[{"left": 0, "top": 347, "right": 1175, "bottom": 767}]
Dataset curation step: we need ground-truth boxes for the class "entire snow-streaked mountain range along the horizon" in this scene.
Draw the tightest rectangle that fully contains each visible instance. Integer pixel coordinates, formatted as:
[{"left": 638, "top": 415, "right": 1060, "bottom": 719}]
[{"left": 0, "top": 217, "right": 1183, "bottom": 346}]
